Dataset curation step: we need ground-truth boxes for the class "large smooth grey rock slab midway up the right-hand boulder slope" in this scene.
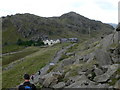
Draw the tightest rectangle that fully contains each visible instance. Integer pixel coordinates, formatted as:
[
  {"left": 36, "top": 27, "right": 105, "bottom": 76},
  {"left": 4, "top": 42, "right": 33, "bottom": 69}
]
[{"left": 95, "top": 49, "right": 112, "bottom": 66}]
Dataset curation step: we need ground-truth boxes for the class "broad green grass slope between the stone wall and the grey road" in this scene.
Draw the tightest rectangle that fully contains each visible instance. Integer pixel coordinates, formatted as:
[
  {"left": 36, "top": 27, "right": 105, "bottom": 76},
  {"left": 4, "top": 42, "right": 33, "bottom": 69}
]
[{"left": 2, "top": 44, "right": 70, "bottom": 88}]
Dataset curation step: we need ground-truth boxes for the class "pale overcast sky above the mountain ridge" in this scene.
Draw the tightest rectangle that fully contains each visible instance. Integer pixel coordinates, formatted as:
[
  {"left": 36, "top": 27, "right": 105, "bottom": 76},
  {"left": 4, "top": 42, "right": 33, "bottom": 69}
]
[{"left": 0, "top": 0, "right": 120, "bottom": 23}]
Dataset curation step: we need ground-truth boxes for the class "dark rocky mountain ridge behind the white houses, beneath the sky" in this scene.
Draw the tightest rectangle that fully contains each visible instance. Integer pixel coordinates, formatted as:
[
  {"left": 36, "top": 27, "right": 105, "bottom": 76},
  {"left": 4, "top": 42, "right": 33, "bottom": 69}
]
[{"left": 2, "top": 12, "right": 114, "bottom": 44}]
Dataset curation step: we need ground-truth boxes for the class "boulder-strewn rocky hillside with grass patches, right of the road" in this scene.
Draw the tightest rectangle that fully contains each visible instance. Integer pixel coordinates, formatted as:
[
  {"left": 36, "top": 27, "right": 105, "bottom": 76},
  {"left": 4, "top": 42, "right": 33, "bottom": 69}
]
[{"left": 31, "top": 24, "right": 120, "bottom": 89}]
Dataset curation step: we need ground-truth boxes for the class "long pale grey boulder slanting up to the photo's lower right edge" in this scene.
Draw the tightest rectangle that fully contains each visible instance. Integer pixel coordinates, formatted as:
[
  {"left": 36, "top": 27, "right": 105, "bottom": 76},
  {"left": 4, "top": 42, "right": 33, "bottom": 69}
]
[{"left": 94, "top": 64, "right": 118, "bottom": 83}]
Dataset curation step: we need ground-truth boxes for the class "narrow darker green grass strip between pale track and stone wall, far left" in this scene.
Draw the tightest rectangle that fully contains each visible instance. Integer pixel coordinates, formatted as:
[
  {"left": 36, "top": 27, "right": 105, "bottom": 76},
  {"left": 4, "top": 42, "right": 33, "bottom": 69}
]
[{"left": 2, "top": 47, "right": 39, "bottom": 65}]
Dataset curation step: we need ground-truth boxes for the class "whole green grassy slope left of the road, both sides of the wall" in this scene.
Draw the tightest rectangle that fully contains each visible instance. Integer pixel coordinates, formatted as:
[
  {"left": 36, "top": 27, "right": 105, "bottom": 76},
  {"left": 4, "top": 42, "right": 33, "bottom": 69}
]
[{"left": 2, "top": 43, "right": 70, "bottom": 88}]
